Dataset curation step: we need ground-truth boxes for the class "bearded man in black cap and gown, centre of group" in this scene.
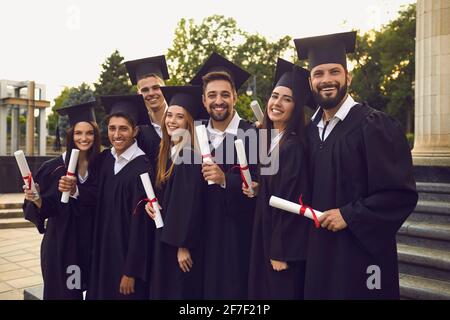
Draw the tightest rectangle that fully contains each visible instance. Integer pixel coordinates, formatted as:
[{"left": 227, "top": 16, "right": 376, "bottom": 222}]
[{"left": 191, "top": 53, "right": 258, "bottom": 299}]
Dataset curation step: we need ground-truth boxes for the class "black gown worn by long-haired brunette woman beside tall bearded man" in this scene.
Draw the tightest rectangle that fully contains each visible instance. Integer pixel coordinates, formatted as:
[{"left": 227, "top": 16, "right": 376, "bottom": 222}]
[{"left": 249, "top": 135, "right": 311, "bottom": 299}]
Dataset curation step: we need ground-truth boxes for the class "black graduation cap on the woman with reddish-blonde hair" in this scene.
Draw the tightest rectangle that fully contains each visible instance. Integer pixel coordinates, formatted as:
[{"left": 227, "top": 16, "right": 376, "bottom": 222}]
[{"left": 161, "top": 86, "right": 209, "bottom": 120}]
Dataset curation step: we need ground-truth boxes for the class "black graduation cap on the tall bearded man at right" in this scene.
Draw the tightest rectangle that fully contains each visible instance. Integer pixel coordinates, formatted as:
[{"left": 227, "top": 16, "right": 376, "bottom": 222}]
[{"left": 294, "top": 31, "right": 356, "bottom": 70}]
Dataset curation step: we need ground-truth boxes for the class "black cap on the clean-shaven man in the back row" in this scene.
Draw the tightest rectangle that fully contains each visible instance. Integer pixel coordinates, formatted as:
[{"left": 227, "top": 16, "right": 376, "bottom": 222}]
[{"left": 125, "top": 56, "right": 169, "bottom": 84}]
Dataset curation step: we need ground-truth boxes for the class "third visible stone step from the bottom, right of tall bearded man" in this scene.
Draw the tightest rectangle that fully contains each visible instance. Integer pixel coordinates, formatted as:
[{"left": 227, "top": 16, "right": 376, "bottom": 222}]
[{"left": 398, "top": 220, "right": 450, "bottom": 241}]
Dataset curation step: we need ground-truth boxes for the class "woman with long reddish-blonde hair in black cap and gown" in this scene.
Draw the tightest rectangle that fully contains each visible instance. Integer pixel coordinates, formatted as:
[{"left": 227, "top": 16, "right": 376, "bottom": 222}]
[{"left": 146, "top": 86, "right": 207, "bottom": 300}]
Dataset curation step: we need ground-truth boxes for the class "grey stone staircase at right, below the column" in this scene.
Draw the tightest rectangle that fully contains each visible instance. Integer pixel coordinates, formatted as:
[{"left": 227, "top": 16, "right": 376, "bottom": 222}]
[{"left": 397, "top": 182, "right": 450, "bottom": 300}]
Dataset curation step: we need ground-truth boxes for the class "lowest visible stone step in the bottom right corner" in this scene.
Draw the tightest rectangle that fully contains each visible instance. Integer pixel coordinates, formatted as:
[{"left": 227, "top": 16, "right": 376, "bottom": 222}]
[{"left": 400, "top": 274, "right": 450, "bottom": 300}]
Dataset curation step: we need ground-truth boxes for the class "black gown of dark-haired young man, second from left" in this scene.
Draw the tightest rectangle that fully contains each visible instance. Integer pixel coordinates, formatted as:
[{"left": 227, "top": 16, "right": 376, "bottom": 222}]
[{"left": 87, "top": 149, "right": 154, "bottom": 300}]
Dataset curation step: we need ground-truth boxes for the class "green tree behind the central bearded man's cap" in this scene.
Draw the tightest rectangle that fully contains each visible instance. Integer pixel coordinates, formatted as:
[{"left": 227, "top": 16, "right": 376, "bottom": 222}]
[{"left": 167, "top": 15, "right": 291, "bottom": 119}]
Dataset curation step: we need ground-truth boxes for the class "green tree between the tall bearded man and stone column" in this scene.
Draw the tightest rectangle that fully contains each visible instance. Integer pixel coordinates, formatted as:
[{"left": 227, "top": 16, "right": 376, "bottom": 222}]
[{"left": 352, "top": 4, "right": 416, "bottom": 133}]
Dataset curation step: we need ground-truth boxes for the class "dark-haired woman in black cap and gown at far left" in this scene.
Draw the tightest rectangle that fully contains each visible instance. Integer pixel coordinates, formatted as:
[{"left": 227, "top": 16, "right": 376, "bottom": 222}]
[{"left": 23, "top": 102, "right": 100, "bottom": 300}]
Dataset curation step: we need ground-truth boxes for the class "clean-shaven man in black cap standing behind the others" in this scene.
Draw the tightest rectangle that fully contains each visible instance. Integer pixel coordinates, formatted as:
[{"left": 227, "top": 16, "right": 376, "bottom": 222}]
[{"left": 125, "top": 55, "right": 169, "bottom": 167}]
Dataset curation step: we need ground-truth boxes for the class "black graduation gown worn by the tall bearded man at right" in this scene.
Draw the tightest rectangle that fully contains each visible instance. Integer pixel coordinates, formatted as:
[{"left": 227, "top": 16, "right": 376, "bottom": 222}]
[{"left": 305, "top": 104, "right": 418, "bottom": 299}]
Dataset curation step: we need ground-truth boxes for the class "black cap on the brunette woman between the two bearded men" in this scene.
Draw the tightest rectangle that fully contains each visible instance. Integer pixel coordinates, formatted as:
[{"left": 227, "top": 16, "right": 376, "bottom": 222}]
[{"left": 273, "top": 58, "right": 315, "bottom": 108}]
